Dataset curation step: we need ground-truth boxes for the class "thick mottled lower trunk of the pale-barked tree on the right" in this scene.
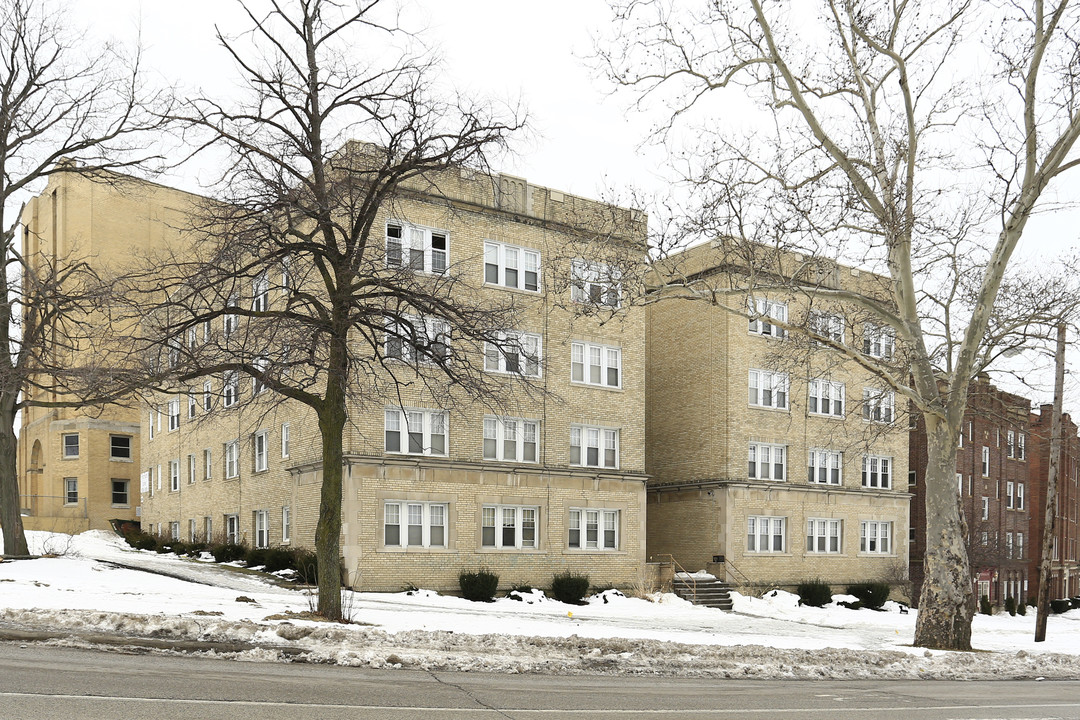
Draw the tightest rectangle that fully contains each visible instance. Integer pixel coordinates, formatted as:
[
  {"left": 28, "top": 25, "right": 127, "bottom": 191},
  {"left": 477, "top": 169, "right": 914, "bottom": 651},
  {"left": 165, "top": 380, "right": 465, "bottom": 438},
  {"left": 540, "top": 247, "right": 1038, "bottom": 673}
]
[{"left": 915, "top": 418, "right": 975, "bottom": 650}]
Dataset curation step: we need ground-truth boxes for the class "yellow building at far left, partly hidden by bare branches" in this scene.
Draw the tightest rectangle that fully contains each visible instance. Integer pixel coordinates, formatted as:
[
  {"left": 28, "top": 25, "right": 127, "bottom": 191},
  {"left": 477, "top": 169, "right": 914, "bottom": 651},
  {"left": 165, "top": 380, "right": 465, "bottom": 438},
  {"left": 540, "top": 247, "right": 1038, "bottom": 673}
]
[{"left": 17, "top": 173, "right": 204, "bottom": 532}]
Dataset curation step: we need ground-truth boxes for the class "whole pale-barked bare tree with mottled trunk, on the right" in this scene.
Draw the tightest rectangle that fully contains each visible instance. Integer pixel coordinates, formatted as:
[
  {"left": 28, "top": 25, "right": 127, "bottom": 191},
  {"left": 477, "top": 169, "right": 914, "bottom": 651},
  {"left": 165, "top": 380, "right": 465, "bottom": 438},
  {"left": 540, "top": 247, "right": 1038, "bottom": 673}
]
[{"left": 599, "top": 0, "right": 1080, "bottom": 649}]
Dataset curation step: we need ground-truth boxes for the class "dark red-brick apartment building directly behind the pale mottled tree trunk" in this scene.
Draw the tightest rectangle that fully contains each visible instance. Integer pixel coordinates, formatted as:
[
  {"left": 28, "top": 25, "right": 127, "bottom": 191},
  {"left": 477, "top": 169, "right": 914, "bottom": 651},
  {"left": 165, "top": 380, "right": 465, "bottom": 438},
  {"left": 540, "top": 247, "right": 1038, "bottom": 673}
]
[{"left": 908, "top": 376, "right": 1038, "bottom": 606}]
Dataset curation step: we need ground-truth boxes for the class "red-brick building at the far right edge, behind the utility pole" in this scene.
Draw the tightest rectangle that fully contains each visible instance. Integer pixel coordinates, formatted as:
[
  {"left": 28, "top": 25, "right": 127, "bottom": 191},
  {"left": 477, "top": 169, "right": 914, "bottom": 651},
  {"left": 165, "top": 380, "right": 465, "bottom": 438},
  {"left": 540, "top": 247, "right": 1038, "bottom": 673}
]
[{"left": 1027, "top": 405, "right": 1080, "bottom": 599}]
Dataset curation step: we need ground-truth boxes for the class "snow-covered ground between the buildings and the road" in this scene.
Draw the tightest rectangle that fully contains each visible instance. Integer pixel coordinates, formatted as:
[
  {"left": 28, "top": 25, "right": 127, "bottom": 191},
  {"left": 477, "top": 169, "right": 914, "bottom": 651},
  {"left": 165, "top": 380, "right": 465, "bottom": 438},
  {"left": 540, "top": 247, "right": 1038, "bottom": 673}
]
[{"left": 0, "top": 531, "right": 1080, "bottom": 679}]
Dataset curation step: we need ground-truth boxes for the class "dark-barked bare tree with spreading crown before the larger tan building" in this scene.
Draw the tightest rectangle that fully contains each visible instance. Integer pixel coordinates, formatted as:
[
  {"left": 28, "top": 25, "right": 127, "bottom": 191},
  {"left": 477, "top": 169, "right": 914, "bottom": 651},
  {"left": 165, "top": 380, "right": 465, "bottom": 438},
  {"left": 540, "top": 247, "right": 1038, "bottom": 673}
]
[{"left": 124, "top": 0, "right": 529, "bottom": 620}]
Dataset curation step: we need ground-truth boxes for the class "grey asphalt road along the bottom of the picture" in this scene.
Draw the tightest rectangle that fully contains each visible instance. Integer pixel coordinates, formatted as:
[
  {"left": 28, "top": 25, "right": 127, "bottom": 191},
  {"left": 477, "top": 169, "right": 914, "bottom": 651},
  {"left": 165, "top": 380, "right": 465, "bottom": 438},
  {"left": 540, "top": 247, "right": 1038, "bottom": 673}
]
[{"left": 0, "top": 643, "right": 1080, "bottom": 720}]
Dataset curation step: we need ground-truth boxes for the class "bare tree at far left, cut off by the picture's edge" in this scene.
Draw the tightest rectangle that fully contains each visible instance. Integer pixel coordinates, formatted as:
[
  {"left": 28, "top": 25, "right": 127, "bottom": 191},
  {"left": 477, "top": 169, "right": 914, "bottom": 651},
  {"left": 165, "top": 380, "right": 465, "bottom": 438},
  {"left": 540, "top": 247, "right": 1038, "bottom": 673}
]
[{"left": 0, "top": 0, "right": 168, "bottom": 555}]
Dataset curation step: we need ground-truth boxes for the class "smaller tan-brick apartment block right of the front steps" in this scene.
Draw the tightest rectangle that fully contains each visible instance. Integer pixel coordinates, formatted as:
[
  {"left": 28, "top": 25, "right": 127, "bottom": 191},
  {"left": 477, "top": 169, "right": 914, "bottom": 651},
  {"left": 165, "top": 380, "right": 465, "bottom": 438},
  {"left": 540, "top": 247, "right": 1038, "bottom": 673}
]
[{"left": 646, "top": 245, "right": 909, "bottom": 589}]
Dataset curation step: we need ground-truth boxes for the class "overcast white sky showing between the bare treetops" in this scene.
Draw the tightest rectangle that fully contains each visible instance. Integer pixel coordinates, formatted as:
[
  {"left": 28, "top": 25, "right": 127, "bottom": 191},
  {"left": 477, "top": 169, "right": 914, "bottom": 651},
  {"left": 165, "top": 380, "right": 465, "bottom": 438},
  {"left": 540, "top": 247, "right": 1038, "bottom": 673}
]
[{"left": 71, "top": 0, "right": 1080, "bottom": 411}]
